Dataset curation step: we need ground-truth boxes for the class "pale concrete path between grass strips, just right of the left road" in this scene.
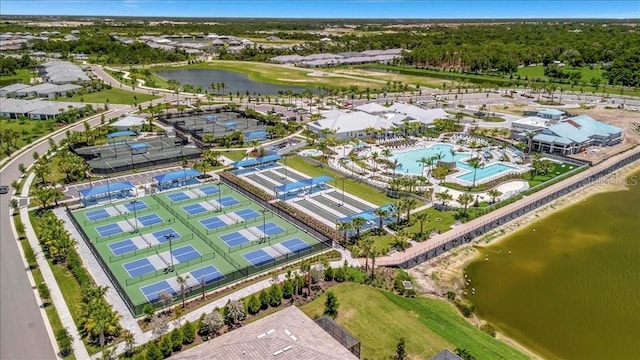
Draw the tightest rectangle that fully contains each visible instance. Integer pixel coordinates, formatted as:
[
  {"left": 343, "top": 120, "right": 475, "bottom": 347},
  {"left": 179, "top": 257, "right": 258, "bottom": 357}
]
[{"left": 20, "top": 172, "right": 89, "bottom": 359}]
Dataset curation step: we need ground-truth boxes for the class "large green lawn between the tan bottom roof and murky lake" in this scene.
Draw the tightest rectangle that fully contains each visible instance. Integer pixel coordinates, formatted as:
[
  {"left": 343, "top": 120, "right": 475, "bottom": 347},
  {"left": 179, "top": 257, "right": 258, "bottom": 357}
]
[{"left": 301, "top": 283, "right": 527, "bottom": 359}]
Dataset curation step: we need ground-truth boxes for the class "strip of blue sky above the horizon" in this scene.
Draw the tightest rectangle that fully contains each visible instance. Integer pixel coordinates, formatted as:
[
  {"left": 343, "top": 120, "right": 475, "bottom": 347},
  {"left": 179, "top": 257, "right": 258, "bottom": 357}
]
[{"left": 0, "top": 0, "right": 640, "bottom": 19}]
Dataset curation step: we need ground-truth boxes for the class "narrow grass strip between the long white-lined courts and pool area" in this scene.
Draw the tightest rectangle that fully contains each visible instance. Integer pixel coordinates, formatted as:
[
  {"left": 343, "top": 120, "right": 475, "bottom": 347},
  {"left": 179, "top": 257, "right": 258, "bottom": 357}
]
[{"left": 282, "top": 156, "right": 395, "bottom": 206}]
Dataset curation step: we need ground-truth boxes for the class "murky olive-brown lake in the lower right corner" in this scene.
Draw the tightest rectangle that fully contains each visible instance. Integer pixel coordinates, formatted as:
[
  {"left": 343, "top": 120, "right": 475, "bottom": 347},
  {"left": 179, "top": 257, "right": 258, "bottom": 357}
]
[{"left": 466, "top": 172, "right": 640, "bottom": 359}]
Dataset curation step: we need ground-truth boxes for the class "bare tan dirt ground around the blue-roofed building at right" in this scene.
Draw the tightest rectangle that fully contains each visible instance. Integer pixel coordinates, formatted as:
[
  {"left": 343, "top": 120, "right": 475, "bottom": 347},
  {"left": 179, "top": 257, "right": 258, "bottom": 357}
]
[{"left": 570, "top": 107, "right": 640, "bottom": 163}]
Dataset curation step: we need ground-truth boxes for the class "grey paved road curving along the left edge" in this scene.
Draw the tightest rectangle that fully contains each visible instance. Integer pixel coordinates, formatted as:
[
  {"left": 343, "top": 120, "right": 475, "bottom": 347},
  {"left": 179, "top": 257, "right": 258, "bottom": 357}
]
[{"left": 0, "top": 100, "right": 145, "bottom": 360}]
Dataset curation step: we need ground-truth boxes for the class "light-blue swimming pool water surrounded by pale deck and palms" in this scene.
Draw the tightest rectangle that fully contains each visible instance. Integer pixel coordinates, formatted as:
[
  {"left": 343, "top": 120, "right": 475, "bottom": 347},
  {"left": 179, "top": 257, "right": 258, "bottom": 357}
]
[{"left": 392, "top": 144, "right": 517, "bottom": 183}]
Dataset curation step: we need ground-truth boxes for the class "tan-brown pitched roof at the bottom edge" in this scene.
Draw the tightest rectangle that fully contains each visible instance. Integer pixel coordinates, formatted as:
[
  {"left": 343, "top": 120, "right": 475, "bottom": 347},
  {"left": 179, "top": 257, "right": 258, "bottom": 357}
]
[{"left": 170, "top": 306, "right": 357, "bottom": 360}]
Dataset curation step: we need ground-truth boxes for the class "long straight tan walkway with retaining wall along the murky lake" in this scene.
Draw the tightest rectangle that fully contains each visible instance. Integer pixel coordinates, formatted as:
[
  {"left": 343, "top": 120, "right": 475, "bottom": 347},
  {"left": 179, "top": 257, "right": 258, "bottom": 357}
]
[{"left": 376, "top": 147, "right": 640, "bottom": 268}]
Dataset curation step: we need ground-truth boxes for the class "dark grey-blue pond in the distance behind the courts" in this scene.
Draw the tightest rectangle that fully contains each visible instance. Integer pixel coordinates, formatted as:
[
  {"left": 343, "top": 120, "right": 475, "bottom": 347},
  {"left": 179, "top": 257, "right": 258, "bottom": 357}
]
[{"left": 156, "top": 69, "right": 312, "bottom": 95}]
